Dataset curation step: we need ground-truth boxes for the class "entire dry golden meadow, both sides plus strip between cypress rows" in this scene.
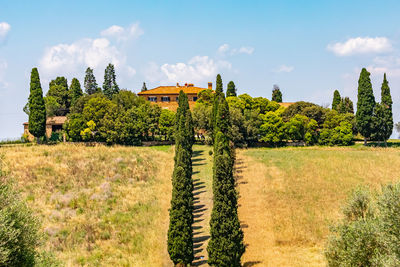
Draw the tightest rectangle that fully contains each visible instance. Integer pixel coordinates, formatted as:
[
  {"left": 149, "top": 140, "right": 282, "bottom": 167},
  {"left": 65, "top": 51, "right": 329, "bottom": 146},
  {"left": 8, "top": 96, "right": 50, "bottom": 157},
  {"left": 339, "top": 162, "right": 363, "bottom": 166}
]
[{"left": 0, "top": 144, "right": 400, "bottom": 266}]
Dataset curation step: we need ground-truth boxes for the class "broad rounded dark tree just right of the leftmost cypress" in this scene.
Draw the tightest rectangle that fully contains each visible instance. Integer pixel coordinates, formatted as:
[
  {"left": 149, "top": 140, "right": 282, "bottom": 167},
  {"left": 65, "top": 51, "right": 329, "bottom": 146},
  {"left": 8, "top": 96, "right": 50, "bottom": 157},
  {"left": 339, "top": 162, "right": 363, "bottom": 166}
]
[{"left": 46, "top": 77, "right": 71, "bottom": 116}]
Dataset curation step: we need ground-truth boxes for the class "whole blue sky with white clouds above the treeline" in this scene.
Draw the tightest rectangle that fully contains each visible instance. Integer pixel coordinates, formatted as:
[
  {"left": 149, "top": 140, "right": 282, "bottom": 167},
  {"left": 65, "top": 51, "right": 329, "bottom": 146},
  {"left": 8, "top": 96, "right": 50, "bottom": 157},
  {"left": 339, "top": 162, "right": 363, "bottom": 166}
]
[{"left": 0, "top": 0, "right": 400, "bottom": 140}]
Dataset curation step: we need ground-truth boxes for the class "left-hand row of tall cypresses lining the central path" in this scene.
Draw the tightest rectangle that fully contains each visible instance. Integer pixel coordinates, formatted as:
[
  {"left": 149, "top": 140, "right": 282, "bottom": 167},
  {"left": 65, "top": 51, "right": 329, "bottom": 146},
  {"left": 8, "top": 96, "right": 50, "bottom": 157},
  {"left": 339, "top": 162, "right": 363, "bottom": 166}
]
[{"left": 168, "top": 91, "right": 194, "bottom": 266}]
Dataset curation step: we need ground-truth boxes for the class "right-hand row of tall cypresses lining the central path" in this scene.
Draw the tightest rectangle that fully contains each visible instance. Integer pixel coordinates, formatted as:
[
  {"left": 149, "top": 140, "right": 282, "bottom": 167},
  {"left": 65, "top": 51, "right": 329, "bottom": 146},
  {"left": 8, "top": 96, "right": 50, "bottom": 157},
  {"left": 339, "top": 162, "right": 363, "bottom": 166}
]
[{"left": 207, "top": 89, "right": 245, "bottom": 267}]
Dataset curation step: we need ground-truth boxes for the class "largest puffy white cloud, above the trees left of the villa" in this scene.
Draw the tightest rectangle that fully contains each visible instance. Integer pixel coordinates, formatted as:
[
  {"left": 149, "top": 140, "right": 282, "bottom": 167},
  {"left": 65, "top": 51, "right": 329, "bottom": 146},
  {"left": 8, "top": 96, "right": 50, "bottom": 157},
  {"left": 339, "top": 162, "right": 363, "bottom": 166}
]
[{"left": 39, "top": 24, "right": 143, "bottom": 86}]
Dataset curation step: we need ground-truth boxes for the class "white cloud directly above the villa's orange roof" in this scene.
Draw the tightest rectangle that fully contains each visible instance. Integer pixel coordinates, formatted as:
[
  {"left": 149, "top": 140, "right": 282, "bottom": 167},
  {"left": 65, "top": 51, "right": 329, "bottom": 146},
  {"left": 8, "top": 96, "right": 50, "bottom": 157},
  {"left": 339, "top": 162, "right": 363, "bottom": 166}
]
[{"left": 145, "top": 56, "right": 232, "bottom": 84}]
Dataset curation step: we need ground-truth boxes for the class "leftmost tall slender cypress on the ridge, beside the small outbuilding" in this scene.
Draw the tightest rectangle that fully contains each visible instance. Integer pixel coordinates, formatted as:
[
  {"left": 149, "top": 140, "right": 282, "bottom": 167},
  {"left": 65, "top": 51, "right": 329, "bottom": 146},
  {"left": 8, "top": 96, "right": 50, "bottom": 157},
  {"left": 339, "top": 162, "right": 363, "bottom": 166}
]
[{"left": 29, "top": 68, "right": 46, "bottom": 142}]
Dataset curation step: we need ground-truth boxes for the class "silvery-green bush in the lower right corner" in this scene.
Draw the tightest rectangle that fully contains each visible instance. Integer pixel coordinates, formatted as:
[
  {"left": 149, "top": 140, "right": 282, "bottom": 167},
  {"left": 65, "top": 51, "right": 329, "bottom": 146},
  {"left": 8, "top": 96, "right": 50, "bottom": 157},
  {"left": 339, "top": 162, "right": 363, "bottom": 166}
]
[{"left": 325, "top": 184, "right": 400, "bottom": 266}]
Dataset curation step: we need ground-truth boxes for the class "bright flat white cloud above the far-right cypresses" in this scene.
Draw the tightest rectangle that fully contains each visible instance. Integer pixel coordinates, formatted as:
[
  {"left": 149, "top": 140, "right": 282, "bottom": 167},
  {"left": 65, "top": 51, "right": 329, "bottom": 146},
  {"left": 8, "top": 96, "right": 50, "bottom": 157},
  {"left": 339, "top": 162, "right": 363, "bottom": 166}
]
[{"left": 327, "top": 37, "right": 392, "bottom": 56}]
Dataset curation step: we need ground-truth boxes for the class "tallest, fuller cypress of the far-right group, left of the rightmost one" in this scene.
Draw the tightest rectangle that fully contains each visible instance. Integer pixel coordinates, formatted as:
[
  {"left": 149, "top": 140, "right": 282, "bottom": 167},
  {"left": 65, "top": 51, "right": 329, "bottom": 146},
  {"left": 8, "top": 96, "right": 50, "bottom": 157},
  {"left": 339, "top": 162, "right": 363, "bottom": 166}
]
[{"left": 356, "top": 68, "right": 375, "bottom": 145}]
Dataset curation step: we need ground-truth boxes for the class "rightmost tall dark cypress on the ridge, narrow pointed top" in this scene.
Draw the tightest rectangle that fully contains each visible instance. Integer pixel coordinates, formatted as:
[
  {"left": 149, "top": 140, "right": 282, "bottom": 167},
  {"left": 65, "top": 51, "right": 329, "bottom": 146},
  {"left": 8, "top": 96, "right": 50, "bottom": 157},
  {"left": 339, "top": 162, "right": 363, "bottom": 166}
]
[{"left": 373, "top": 73, "right": 393, "bottom": 146}]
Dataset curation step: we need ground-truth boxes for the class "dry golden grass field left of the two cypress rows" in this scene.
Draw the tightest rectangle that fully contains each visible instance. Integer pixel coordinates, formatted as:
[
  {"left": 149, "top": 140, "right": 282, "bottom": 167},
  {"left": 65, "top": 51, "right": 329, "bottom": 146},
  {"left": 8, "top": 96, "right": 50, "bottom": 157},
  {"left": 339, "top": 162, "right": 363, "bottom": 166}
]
[{"left": 0, "top": 145, "right": 173, "bottom": 266}]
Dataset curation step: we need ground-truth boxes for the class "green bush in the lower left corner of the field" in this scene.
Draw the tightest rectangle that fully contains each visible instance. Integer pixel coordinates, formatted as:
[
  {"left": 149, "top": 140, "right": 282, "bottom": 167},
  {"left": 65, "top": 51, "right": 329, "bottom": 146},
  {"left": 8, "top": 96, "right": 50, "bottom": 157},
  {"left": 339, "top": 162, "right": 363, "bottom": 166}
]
[{"left": 0, "top": 180, "right": 39, "bottom": 266}]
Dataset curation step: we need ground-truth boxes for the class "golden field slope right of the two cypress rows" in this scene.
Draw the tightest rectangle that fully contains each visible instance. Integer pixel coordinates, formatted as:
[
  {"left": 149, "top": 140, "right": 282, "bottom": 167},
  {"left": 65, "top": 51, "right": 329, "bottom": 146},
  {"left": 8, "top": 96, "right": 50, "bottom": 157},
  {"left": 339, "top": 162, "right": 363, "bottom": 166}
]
[{"left": 236, "top": 147, "right": 400, "bottom": 266}]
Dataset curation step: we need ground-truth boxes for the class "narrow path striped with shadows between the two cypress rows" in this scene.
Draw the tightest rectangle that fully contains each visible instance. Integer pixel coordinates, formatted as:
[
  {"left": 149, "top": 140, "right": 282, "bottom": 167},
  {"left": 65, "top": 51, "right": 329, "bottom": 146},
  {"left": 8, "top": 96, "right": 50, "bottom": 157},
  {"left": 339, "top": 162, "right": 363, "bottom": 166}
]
[{"left": 192, "top": 146, "right": 212, "bottom": 266}]
